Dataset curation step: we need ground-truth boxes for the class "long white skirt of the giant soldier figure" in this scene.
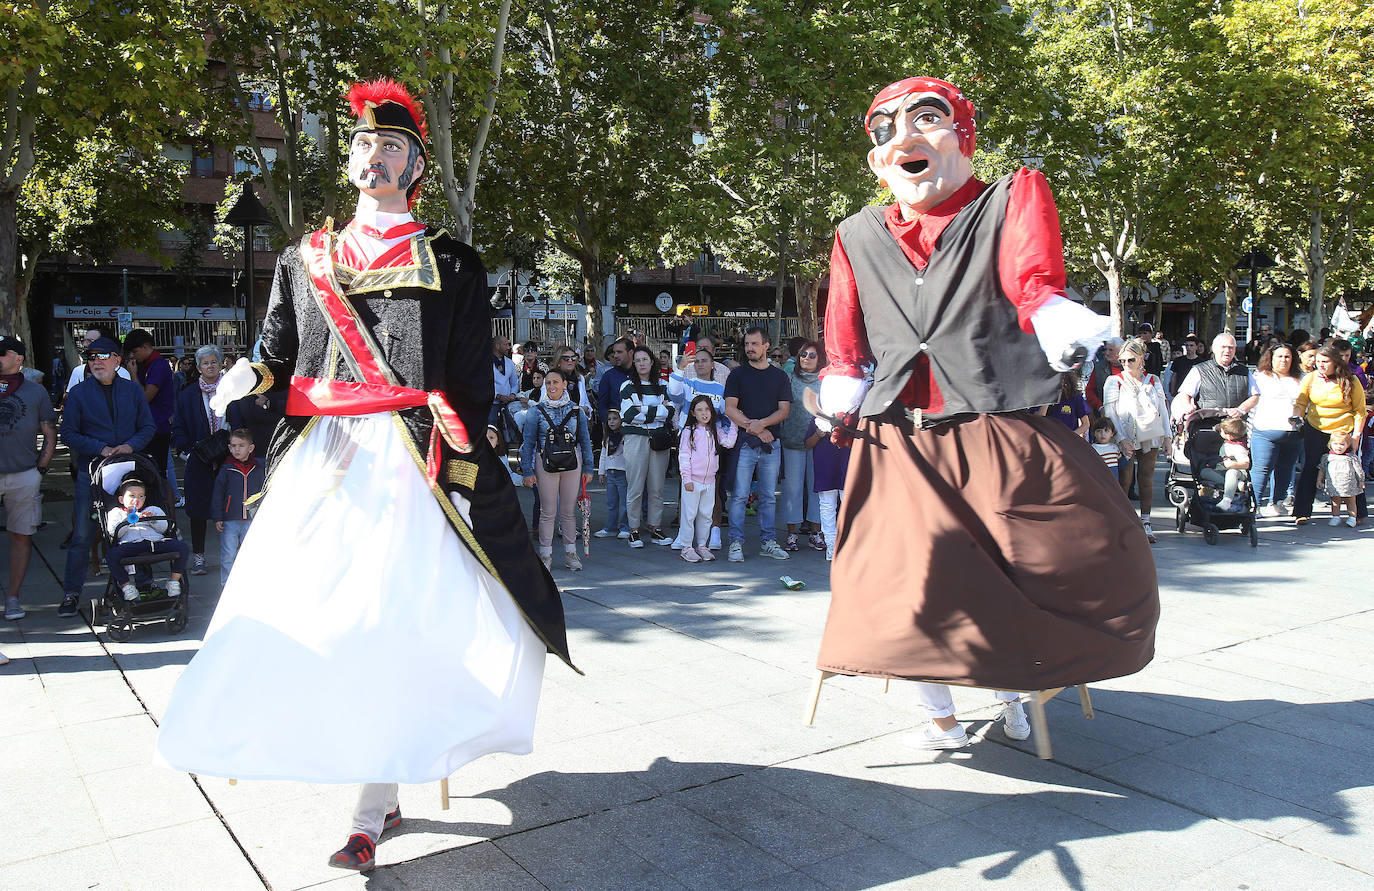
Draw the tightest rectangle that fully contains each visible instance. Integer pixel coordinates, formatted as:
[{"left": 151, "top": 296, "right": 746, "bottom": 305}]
[{"left": 158, "top": 413, "right": 544, "bottom": 782}]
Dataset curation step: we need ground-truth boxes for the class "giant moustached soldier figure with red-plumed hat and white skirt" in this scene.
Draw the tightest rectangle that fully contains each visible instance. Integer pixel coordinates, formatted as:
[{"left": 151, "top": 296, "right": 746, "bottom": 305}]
[{"left": 158, "top": 81, "right": 572, "bottom": 872}]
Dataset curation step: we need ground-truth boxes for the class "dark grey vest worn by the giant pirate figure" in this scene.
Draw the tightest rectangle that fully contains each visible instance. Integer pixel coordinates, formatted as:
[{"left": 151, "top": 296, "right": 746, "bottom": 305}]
[{"left": 840, "top": 176, "right": 1059, "bottom": 426}]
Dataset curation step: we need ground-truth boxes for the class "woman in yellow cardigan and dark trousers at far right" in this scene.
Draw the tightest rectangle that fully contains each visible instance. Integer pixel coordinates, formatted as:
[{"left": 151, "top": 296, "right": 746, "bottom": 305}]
[{"left": 1293, "top": 347, "right": 1369, "bottom": 525}]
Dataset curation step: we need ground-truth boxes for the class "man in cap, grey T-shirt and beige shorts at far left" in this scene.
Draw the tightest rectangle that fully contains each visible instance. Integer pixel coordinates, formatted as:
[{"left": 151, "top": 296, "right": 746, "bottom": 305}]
[{"left": 0, "top": 337, "right": 58, "bottom": 622}]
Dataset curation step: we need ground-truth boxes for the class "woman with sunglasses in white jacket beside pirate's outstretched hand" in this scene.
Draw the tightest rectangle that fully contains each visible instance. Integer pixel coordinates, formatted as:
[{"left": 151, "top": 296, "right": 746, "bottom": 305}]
[{"left": 1102, "top": 337, "right": 1169, "bottom": 545}]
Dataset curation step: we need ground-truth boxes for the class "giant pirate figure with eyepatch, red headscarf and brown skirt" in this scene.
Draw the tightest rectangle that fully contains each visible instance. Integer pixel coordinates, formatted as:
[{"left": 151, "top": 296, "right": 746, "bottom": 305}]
[{"left": 818, "top": 77, "right": 1158, "bottom": 748}]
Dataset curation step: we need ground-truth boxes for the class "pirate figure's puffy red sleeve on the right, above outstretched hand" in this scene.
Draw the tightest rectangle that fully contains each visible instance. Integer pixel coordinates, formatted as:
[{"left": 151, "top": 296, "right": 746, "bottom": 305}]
[{"left": 998, "top": 168, "right": 1065, "bottom": 334}]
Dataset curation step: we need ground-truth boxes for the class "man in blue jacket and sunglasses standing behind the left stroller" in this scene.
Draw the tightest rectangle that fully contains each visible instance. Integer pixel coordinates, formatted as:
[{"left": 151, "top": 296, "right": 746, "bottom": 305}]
[{"left": 58, "top": 337, "right": 157, "bottom": 616}]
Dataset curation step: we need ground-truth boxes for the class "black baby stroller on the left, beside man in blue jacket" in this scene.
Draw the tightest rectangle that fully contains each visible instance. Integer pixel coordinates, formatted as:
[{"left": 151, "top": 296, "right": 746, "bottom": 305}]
[{"left": 91, "top": 452, "right": 191, "bottom": 642}]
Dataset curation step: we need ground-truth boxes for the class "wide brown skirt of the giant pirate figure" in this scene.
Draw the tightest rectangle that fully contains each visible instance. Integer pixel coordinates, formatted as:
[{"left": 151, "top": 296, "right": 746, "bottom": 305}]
[{"left": 818, "top": 413, "right": 1160, "bottom": 690}]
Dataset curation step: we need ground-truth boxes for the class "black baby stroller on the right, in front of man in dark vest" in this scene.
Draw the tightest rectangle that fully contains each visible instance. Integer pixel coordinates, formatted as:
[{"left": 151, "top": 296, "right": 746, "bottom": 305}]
[{"left": 1164, "top": 410, "right": 1260, "bottom": 547}]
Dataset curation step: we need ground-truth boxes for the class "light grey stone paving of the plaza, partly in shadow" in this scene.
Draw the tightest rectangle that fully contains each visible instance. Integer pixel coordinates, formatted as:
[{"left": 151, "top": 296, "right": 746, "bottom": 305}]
[{"left": 0, "top": 462, "right": 1374, "bottom": 891}]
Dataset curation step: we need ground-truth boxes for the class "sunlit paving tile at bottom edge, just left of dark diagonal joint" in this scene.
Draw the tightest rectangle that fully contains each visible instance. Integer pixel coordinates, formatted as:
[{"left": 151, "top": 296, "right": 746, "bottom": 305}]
[{"left": 110, "top": 817, "right": 264, "bottom": 891}]
